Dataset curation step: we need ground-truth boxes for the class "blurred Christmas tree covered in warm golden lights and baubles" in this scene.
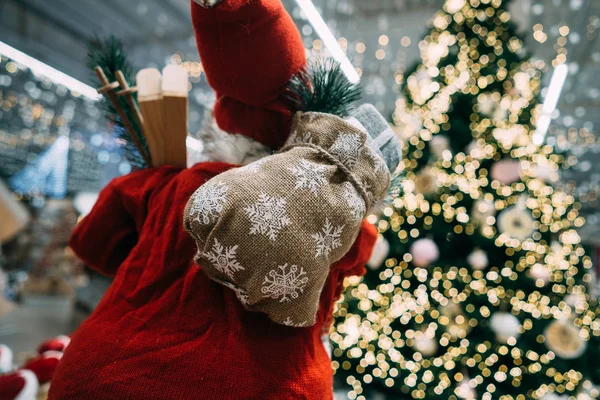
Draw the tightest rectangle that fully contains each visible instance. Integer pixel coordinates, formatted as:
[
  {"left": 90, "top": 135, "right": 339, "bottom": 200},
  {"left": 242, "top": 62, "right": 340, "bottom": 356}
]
[{"left": 331, "top": 0, "right": 600, "bottom": 400}]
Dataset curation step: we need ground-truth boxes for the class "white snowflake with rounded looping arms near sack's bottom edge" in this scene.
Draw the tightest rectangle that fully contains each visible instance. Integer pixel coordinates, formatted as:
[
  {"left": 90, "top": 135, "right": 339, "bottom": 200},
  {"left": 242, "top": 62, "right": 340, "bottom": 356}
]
[{"left": 261, "top": 263, "right": 308, "bottom": 303}]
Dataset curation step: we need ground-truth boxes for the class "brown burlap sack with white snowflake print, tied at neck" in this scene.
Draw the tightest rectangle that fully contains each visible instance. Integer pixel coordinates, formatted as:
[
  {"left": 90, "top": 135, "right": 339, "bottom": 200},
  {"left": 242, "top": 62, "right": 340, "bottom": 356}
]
[{"left": 184, "top": 113, "right": 390, "bottom": 326}]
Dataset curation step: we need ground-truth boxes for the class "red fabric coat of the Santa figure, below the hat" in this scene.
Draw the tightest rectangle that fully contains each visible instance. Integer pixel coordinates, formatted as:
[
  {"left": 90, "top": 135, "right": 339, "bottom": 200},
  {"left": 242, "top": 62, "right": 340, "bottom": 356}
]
[{"left": 49, "top": 163, "right": 376, "bottom": 400}]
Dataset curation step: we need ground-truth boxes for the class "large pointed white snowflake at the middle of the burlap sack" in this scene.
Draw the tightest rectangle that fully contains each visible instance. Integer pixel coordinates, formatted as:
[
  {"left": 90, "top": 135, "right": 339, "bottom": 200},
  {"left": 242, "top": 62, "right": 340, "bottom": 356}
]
[{"left": 244, "top": 193, "right": 292, "bottom": 241}]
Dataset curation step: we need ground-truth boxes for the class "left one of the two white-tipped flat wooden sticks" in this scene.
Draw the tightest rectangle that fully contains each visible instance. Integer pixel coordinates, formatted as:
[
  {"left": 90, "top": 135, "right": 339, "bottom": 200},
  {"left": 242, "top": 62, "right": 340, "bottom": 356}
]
[{"left": 136, "top": 68, "right": 165, "bottom": 167}]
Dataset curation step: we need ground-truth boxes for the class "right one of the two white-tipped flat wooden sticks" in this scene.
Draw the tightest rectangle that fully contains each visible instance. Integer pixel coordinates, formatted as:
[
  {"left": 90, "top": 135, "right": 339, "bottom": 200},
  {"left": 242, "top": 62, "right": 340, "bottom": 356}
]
[{"left": 162, "top": 64, "right": 189, "bottom": 168}]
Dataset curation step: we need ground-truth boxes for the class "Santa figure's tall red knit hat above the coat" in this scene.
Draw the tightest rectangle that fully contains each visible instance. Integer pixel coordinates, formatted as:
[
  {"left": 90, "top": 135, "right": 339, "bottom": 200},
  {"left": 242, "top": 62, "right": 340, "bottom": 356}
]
[{"left": 192, "top": 0, "right": 306, "bottom": 148}]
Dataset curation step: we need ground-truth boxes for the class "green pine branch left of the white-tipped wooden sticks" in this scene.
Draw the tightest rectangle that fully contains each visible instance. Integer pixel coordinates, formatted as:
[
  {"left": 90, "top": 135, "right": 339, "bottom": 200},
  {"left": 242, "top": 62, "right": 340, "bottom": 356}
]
[{"left": 88, "top": 35, "right": 150, "bottom": 169}]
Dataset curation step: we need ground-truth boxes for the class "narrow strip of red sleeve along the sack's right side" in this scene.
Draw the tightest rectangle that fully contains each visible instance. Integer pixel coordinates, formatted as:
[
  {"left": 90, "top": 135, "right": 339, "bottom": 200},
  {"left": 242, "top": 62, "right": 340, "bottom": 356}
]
[{"left": 317, "top": 220, "right": 377, "bottom": 328}]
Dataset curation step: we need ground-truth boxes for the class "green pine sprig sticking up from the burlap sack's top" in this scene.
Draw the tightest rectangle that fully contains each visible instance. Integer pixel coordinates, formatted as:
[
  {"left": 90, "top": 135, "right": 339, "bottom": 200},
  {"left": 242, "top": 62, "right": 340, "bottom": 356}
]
[{"left": 286, "top": 59, "right": 361, "bottom": 117}]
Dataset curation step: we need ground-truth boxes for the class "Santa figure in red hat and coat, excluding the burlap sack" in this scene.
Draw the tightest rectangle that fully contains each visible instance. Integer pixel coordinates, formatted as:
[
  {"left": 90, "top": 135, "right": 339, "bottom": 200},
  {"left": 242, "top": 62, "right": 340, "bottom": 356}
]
[{"left": 17, "top": 0, "right": 377, "bottom": 400}]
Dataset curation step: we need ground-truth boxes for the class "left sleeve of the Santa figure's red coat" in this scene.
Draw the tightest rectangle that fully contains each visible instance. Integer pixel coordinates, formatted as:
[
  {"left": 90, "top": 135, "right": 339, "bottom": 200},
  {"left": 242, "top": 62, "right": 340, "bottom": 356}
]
[{"left": 69, "top": 167, "right": 177, "bottom": 276}]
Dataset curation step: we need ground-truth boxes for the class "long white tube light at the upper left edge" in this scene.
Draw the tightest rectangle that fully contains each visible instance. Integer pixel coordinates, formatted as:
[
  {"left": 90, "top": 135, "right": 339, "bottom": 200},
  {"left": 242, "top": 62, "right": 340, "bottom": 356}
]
[{"left": 0, "top": 42, "right": 100, "bottom": 100}]
